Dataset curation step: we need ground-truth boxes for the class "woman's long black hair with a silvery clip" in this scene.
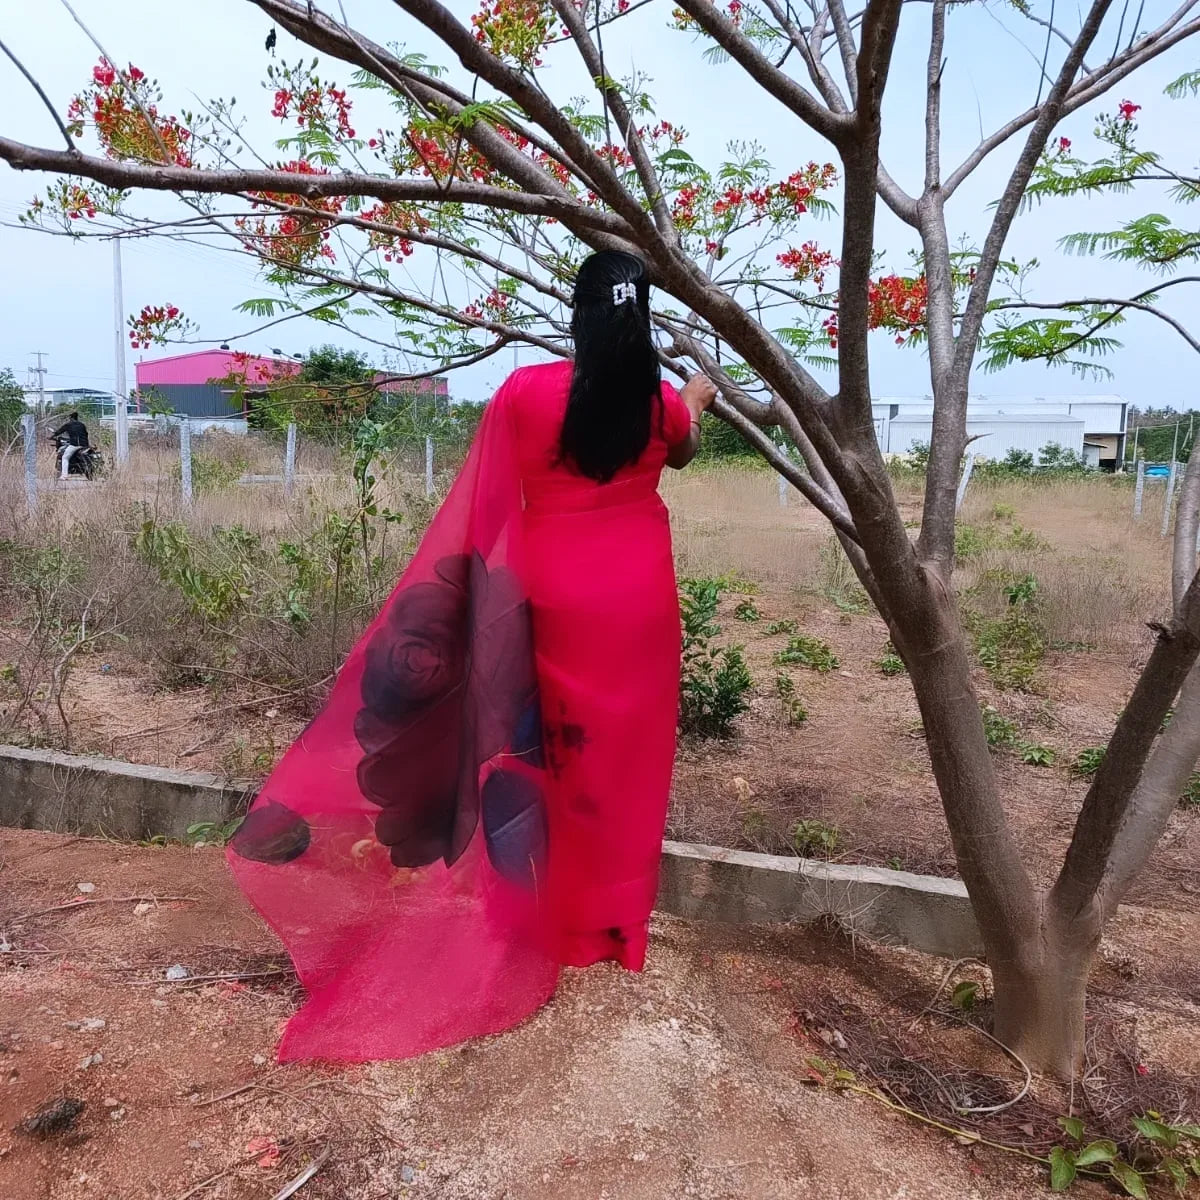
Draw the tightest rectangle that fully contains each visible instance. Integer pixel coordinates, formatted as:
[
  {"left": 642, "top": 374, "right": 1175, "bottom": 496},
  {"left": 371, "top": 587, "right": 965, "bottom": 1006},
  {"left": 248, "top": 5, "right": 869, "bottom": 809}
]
[{"left": 559, "top": 250, "right": 662, "bottom": 484}]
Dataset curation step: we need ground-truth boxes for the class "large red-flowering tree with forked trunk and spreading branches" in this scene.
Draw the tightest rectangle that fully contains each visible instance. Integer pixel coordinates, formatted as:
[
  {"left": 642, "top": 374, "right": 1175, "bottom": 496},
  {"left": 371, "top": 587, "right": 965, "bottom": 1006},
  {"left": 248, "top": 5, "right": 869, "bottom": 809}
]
[{"left": 0, "top": 0, "right": 1200, "bottom": 1074}]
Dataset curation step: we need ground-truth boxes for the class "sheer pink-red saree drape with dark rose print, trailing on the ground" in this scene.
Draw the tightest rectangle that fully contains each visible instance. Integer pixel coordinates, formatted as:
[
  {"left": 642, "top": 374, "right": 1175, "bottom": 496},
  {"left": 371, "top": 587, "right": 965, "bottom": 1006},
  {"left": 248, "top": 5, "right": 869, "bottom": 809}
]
[{"left": 229, "top": 386, "right": 557, "bottom": 1061}]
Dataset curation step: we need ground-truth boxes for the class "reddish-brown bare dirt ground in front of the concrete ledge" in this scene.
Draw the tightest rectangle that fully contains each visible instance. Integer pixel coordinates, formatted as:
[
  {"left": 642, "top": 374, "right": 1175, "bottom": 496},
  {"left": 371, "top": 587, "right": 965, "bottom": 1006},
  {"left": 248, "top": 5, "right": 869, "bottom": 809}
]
[{"left": 0, "top": 830, "right": 1200, "bottom": 1200}]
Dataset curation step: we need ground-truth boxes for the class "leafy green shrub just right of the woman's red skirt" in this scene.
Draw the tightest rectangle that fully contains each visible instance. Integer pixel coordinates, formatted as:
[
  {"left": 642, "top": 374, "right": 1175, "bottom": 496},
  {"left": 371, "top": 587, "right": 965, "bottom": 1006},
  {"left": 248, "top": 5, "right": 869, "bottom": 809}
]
[{"left": 679, "top": 580, "right": 752, "bottom": 738}]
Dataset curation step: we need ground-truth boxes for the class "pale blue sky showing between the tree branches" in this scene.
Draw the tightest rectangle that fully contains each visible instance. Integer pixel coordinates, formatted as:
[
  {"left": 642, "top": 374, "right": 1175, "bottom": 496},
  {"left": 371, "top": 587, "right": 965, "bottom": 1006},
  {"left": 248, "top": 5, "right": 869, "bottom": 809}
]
[{"left": 0, "top": 0, "right": 1200, "bottom": 409}]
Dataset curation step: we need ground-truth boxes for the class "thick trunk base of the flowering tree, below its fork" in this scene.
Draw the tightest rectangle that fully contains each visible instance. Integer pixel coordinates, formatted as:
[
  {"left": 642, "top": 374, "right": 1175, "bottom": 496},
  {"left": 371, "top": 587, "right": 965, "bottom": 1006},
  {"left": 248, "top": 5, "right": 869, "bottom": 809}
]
[{"left": 990, "top": 913, "right": 1100, "bottom": 1080}]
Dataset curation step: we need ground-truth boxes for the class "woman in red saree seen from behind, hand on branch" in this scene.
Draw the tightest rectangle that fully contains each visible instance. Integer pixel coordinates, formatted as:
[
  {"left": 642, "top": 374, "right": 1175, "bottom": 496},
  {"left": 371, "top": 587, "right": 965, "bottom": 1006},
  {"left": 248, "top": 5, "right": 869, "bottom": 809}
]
[{"left": 229, "top": 252, "right": 715, "bottom": 1061}]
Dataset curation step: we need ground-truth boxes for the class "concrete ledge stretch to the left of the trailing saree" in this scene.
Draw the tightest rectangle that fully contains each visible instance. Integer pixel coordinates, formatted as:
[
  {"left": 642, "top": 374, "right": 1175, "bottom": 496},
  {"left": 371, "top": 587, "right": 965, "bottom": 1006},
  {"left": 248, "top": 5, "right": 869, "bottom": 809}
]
[{"left": 0, "top": 746, "right": 256, "bottom": 841}]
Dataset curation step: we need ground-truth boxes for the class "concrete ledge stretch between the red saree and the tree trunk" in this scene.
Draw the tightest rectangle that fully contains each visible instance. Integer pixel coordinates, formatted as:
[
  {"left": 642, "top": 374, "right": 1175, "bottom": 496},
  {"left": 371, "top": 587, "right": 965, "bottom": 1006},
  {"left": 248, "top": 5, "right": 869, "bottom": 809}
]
[{"left": 658, "top": 841, "right": 983, "bottom": 959}]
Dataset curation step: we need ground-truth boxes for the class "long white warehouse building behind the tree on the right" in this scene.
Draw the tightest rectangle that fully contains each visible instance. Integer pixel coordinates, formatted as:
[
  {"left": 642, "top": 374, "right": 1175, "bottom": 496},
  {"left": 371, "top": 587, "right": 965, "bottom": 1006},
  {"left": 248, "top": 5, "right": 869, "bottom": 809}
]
[{"left": 871, "top": 395, "right": 1128, "bottom": 470}]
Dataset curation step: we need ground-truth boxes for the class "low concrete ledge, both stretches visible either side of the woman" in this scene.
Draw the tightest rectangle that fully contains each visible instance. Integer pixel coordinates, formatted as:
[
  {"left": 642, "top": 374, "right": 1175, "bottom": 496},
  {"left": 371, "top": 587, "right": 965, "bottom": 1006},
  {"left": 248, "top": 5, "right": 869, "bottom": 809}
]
[{"left": 0, "top": 746, "right": 983, "bottom": 958}]
